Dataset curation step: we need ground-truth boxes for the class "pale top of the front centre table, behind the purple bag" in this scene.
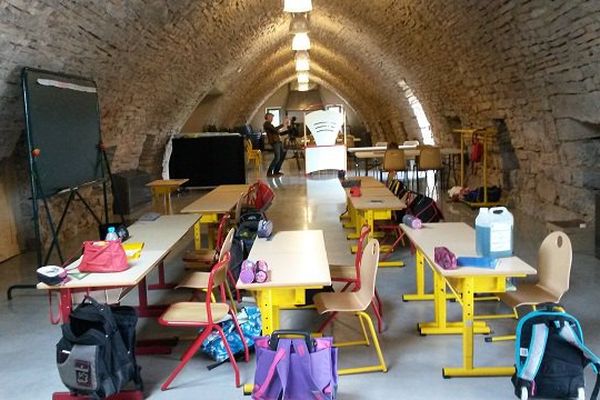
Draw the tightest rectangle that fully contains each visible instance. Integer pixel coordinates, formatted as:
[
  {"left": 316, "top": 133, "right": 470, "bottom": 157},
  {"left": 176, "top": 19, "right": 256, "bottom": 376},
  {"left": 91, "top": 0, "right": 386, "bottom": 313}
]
[{"left": 236, "top": 230, "right": 331, "bottom": 290}]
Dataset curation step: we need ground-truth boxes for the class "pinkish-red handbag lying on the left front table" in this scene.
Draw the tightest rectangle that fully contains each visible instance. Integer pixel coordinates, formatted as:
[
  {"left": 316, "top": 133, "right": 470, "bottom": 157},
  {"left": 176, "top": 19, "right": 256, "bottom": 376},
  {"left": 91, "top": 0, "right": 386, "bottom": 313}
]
[{"left": 78, "top": 240, "right": 129, "bottom": 272}]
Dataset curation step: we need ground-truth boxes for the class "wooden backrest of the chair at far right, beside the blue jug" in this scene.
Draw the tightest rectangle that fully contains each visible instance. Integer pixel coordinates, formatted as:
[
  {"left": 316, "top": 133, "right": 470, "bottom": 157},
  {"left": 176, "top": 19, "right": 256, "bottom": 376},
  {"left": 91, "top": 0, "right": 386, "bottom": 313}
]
[{"left": 538, "top": 232, "right": 573, "bottom": 301}]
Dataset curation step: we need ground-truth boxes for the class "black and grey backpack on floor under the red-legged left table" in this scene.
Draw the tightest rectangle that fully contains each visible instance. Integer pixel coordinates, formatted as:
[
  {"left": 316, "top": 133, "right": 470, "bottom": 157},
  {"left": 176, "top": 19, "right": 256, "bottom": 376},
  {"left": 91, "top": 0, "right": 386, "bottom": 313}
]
[{"left": 56, "top": 296, "right": 142, "bottom": 399}]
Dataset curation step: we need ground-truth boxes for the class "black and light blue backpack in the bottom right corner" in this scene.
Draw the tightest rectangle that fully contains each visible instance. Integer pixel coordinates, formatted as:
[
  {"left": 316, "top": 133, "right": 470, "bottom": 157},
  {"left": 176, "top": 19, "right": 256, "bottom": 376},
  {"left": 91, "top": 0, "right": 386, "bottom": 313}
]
[{"left": 512, "top": 303, "right": 600, "bottom": 400}]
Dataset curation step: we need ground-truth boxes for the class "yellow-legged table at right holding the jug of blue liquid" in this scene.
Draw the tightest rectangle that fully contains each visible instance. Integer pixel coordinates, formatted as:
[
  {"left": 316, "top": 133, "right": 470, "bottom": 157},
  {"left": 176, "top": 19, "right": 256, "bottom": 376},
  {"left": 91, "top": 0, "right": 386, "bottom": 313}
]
[{"left": 400, "top": 222, "right": 536, "bottom": 377}]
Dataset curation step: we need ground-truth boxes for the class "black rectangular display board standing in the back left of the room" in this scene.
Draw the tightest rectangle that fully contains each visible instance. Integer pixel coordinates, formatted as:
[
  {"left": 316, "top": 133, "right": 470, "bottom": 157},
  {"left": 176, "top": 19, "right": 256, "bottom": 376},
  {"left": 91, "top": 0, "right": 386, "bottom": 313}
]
[{"left": 169, "top": 134, "right": 246, "bottom": 187}]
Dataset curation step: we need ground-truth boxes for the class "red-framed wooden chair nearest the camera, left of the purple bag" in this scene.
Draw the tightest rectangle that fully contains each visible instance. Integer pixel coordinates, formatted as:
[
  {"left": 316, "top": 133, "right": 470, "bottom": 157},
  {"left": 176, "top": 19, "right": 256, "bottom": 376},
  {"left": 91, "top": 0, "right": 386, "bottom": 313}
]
[{"left": 158, "top": 252, "right": 250, "bottom": 390}]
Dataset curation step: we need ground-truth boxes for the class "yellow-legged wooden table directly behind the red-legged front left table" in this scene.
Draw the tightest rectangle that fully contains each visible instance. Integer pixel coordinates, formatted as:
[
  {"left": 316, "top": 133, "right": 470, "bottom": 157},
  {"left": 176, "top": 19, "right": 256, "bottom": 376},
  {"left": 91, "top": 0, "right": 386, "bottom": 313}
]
[{"left": 181, "top": 184, "right": 250, "bottom": 250}]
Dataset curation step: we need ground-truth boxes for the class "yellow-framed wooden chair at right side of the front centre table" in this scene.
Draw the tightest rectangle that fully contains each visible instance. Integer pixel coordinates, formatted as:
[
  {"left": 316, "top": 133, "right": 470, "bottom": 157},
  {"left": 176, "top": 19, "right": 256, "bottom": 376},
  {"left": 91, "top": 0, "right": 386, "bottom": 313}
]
[{"left": 314, "top": 239, "right": 387, "bottom": 375}]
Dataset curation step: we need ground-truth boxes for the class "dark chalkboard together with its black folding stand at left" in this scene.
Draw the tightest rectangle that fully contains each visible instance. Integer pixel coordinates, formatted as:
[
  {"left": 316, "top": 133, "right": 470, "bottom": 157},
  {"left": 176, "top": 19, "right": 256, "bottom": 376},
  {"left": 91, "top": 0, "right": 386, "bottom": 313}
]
[{"left": 7, "top": 68, "right": 124, "bottom": 300}]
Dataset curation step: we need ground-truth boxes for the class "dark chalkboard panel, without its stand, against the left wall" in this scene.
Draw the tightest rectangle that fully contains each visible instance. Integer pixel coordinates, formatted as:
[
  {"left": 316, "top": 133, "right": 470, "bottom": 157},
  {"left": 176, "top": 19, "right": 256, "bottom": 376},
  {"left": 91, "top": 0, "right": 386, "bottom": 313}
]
[{"left": 21, "top": 68, "right": 102, "bottom": 197}]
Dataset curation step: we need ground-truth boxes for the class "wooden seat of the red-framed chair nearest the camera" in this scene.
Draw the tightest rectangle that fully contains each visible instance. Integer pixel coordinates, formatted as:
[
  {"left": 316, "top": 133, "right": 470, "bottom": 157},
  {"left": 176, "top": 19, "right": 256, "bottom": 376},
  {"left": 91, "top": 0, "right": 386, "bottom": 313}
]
[{"left": 161, "top": 301, "right": 229, "bottom": 326}]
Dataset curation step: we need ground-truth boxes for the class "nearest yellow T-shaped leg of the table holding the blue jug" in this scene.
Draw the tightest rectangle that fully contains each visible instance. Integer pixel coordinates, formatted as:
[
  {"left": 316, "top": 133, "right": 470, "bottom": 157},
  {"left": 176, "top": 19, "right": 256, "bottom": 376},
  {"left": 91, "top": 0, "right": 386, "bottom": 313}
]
[{"left": 442, "top": 277, "right": 515, "bottom": 378}]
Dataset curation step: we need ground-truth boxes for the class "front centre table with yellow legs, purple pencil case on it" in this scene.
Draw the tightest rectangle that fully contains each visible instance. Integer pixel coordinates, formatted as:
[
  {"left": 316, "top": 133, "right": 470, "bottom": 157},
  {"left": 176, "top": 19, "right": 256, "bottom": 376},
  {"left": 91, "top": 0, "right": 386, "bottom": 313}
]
[{"left": 236, "top": 230, "right": 331, "bottom": 335}]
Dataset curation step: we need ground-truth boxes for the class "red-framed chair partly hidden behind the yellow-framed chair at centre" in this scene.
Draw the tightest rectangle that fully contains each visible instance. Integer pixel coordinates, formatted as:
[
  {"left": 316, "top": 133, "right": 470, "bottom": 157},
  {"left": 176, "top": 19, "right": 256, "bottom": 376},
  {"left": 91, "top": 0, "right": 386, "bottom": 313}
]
[{"left": 318, "top": 224, "right": 383, "bottom": 333}]
